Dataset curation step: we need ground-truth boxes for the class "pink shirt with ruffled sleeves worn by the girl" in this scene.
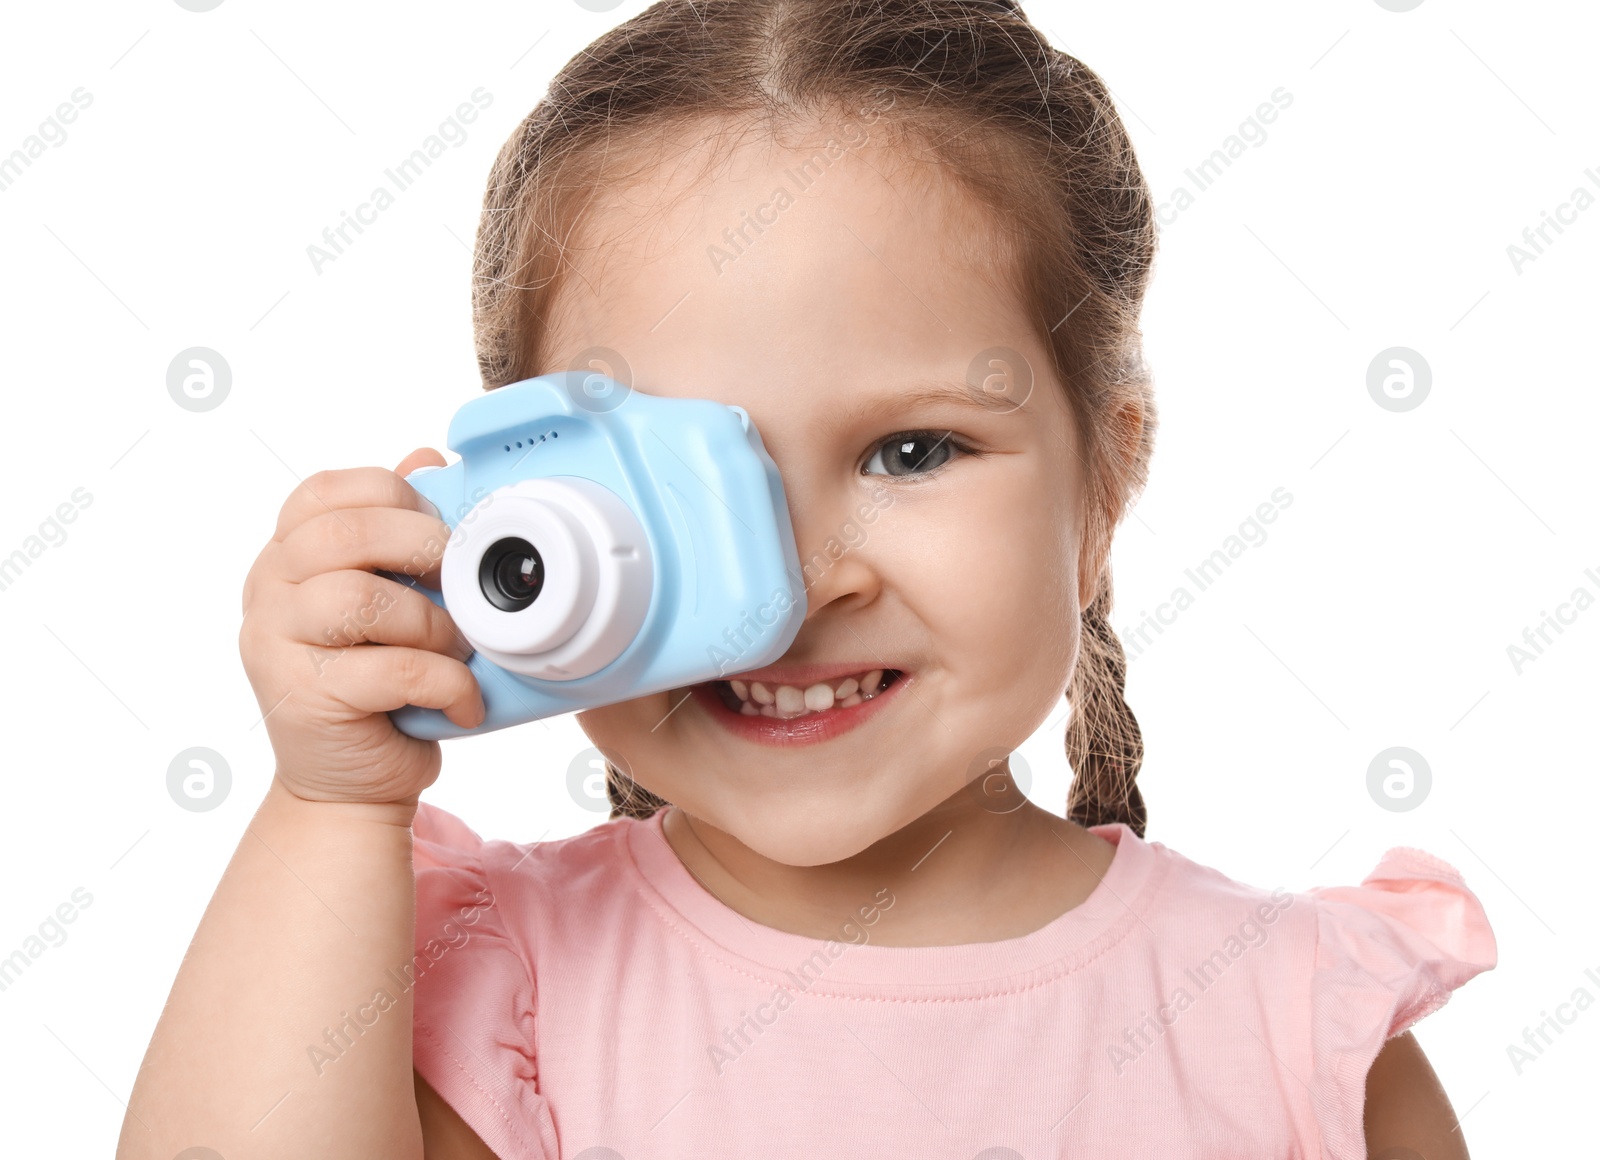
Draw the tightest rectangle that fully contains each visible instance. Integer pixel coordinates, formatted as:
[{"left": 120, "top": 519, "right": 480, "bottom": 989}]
[{"left": 413, "top": 803, "right": 1496, "bottom": 1160}]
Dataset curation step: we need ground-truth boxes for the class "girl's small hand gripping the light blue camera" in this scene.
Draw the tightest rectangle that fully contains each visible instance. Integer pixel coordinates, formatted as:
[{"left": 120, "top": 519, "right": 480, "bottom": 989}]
[{"left": 238, "top": 448, "right": 483, "bottom": 806}]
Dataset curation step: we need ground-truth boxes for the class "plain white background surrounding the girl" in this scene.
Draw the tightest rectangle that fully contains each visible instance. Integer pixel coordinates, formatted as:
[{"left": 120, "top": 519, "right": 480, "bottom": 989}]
[{"left": 0, "top": 0, "right": 1600, "bottom": 1157}]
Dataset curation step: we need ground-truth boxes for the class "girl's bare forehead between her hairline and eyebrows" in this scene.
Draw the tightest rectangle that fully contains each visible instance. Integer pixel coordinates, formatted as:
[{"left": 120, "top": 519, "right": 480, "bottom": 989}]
[{"left": 546, "top": 136, "right": 1029, "bottom": 408}]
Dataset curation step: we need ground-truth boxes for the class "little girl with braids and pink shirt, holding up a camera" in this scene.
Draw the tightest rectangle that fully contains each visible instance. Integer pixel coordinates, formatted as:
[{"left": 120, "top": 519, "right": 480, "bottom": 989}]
[{"left": 118, "top": 0, "right": 1496, "bottom": 1160}]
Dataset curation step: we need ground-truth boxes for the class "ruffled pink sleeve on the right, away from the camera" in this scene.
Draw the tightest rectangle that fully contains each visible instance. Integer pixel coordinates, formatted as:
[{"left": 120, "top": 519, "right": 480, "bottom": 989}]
[{"left": 1309, "top": 848, "right": 1496, "bottom": 1160}]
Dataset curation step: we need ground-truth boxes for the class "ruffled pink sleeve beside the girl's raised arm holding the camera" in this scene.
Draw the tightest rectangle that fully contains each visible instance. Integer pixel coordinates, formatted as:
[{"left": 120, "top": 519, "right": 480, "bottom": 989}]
[{"left": 410, "top": 802, "right": 558, "bottom": 1160}]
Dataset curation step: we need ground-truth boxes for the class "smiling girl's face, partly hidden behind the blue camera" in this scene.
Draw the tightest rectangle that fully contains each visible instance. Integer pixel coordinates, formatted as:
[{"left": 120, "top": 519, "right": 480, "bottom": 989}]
[{"left": 553, "top": 126, "right": 1098, "bottom": 866}]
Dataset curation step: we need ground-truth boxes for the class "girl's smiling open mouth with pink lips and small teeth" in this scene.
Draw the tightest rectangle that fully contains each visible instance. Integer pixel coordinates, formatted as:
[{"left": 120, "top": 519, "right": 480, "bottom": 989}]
[{"left": 693, "top": 669, "right": 910, "bottom": 746}]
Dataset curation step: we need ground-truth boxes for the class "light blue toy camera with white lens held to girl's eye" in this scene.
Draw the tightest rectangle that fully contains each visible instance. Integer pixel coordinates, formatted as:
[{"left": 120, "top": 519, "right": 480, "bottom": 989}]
[{"left": 382, "top": 371, "right": 805, "bottom": 739}]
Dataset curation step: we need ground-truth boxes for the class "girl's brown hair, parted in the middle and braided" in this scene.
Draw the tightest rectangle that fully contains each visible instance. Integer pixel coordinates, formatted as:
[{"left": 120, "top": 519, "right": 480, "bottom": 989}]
[{"left": 472, "top": 0, "right": 1155, "bottom": 835}]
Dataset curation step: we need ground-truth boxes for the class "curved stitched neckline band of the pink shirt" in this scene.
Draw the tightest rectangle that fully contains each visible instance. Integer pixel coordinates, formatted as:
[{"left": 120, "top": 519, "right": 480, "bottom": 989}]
[{"left": 616, "top": 808, "right": 1160, "bottom": 994}]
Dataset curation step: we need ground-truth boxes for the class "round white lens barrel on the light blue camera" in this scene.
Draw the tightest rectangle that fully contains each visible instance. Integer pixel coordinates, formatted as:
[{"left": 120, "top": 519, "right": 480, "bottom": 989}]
[{"left": 440, "top": 475, "right": 654, "bottom": 680}]
